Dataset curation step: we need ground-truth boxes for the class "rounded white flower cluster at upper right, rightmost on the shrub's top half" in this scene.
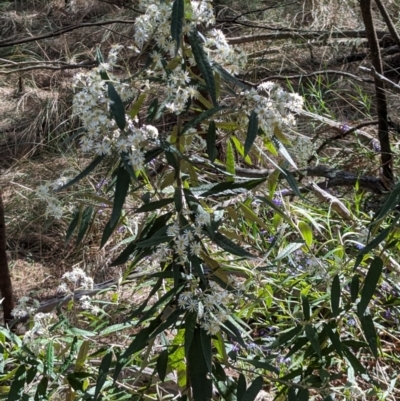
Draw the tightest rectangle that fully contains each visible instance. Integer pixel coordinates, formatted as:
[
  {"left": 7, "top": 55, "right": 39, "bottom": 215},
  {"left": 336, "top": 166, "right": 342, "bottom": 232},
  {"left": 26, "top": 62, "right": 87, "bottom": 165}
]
[{"left": 241, "top": 82, "right": 303, "bottom": 136}]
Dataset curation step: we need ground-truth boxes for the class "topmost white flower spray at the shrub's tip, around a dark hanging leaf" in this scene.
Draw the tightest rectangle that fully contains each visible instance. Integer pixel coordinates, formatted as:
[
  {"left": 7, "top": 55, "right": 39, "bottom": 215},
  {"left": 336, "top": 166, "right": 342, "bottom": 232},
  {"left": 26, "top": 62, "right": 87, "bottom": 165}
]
[{"left": 130, "top": 0, "right": 246, "bottom": 115}]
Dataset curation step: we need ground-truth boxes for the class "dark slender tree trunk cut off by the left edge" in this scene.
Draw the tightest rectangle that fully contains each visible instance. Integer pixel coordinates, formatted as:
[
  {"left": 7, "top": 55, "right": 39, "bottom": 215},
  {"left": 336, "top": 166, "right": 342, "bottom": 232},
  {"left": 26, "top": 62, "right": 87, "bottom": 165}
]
[{"left": 0, "top": 189, "right": 14, "bottom": 323}]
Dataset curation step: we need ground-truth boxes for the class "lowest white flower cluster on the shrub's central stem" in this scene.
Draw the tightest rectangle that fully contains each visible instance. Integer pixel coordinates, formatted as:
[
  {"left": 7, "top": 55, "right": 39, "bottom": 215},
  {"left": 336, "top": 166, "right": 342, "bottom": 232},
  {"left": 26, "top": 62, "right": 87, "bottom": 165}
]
[{"left": 178, "top": 281, "right": 241, "bottom": 335}]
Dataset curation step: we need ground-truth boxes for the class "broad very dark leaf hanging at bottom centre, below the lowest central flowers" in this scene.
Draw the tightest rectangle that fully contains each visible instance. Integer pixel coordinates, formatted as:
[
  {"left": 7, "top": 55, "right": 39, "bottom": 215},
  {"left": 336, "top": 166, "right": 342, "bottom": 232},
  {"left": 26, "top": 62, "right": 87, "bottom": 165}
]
[{"left": 187, "top": 328, "right": 212, "bottom": 401}]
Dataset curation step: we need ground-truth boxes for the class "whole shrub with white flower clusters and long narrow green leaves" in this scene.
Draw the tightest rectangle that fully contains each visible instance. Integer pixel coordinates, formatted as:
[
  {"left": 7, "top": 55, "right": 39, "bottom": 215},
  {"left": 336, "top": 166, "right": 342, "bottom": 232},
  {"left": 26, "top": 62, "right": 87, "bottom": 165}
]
[{"left": 0, "top": 0, "right": 398, "bottom": 401}]
